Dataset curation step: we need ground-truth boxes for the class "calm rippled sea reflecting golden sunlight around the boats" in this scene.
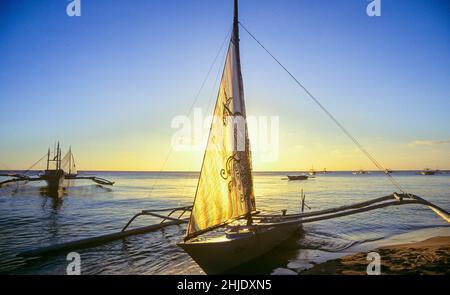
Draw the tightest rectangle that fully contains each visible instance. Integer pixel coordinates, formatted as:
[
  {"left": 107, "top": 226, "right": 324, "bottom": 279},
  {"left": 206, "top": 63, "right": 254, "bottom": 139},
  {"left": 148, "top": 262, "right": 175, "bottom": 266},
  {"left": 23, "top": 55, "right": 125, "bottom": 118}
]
[{"left": 0, "top": 171, "right": 450, "bottom": 274}]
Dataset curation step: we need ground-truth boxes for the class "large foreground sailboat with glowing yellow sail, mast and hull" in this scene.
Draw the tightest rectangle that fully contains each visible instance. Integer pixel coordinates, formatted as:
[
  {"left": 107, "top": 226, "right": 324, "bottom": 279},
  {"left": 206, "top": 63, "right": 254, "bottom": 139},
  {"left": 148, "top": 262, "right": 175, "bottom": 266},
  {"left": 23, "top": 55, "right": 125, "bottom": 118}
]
[{"left": 178, "top": 0, "right": 300, "bottom": 274}]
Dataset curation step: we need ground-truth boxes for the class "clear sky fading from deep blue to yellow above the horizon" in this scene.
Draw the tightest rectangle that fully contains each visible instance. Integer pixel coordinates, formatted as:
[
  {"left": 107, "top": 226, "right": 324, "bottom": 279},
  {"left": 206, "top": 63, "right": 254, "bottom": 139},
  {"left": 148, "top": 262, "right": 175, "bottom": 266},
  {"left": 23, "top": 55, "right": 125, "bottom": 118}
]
[{"left": 0, "top": 0, "right": 450, "bottom": 171}]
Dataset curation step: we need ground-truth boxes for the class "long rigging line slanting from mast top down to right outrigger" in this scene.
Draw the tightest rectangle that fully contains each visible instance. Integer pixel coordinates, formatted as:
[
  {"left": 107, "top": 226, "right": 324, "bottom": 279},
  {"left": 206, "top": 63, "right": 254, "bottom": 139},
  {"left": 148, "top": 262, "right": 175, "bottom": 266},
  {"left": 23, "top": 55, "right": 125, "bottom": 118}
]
[{"left": 239, "top": 22, "right": 406, "bottom": 193}]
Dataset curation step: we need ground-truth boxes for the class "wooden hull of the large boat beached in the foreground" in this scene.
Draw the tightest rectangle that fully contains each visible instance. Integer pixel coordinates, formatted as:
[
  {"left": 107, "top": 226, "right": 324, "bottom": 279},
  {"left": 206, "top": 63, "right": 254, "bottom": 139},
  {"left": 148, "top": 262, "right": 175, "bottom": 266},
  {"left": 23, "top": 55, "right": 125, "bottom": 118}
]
[{"left": 178, "top": 220, "right": 300, "bottom": 274}]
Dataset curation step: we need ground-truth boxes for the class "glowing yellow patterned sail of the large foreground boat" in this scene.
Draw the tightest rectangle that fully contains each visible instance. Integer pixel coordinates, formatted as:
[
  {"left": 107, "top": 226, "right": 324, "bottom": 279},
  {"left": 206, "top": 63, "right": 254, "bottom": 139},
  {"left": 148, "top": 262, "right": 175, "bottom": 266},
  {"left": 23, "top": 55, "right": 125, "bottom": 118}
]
[{"left": 187, "top": 28, "right": 255, "bottom": 238}]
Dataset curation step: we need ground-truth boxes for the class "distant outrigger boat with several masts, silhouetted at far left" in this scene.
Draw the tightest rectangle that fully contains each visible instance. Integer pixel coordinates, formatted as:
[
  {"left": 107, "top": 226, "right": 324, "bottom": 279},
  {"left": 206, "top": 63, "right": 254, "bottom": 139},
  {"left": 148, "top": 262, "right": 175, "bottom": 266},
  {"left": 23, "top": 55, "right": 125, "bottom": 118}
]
[{"left": 0, "top": 142, "right": 114, "bottom": 196}]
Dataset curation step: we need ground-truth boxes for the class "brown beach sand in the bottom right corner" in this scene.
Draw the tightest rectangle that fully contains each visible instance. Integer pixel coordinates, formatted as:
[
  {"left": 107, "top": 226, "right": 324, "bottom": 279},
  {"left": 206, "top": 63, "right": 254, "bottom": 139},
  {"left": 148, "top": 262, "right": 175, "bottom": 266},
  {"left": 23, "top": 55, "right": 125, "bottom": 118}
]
[{"left": 299, "top": 236, "right": 450, "bottom": 275}]
